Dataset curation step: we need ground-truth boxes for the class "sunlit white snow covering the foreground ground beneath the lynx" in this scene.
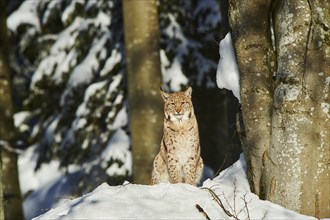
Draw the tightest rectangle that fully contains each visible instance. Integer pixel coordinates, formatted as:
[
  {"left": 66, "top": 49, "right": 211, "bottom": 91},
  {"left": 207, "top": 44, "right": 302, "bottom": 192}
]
[{"left": 34, "top": 155, "right": 315, "bottom": 220}]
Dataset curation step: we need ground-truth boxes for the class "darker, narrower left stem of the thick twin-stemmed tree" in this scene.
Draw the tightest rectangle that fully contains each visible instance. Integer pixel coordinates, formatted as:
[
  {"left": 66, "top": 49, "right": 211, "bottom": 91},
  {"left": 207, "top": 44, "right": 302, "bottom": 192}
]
[{"left": 229, "top": 0, "right": 275, "bottom": 195}]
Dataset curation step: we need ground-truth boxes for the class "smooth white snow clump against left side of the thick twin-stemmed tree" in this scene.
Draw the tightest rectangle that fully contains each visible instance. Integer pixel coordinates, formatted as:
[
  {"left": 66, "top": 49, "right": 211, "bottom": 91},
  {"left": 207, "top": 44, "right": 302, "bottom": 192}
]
[{"left": 217, "top": 33, "right": 240, "bottom": 100}]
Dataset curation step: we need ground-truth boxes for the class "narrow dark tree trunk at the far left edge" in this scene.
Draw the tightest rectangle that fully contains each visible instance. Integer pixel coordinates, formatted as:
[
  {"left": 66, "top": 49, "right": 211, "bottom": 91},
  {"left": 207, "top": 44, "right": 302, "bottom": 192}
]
[{"left": 0, "top": 0, "right": 23, "bottom": 219}]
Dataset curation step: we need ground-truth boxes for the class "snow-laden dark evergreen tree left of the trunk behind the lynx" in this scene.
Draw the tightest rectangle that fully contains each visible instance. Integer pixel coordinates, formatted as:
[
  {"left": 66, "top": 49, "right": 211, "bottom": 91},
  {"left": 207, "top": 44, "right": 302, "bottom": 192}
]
[{"left": 8, "top": 1, "right": 131, "bottom": 192}]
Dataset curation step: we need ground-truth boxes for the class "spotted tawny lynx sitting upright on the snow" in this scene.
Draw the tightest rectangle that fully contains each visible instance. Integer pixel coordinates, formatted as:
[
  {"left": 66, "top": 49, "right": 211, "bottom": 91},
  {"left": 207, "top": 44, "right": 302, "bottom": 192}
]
[{"left": 151, "top": 87, "right": 203, "bottom": 185}]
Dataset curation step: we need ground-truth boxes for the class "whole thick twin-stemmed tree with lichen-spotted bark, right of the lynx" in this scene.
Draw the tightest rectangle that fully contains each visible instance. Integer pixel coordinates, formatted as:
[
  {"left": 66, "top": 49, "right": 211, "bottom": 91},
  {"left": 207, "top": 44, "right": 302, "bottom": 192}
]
[{"left": 230, "top": 0, "right": 330, "bottom": 218}]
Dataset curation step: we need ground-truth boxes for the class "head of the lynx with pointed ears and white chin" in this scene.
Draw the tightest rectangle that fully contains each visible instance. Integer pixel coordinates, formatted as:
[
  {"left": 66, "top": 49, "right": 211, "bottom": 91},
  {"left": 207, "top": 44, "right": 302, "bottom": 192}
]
[{"left": 160, "top": 87, "right": 194, "bottom": 122}]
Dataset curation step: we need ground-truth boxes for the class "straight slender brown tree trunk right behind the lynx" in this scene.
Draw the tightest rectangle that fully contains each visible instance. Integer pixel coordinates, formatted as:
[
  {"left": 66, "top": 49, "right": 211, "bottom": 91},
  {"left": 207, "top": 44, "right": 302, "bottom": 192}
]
[{"left": 123, "top": 0, "right": 163, "bottom": 184}]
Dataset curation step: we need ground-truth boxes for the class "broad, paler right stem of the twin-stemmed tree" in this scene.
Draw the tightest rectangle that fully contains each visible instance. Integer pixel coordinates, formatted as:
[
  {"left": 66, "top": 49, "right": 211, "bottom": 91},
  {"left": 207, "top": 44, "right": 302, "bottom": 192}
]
[{"left": 265, "top": 0, "right": 330, "bottom": 218}]
